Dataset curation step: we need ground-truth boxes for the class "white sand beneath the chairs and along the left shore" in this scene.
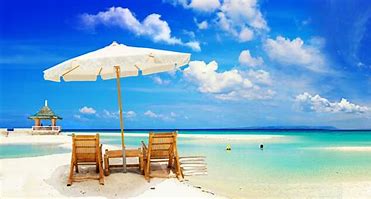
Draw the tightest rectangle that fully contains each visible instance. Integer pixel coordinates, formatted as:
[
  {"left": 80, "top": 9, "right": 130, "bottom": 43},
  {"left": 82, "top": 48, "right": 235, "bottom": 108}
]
[{"left": 0, "top": 135, "right": 224, "bottom": 198}]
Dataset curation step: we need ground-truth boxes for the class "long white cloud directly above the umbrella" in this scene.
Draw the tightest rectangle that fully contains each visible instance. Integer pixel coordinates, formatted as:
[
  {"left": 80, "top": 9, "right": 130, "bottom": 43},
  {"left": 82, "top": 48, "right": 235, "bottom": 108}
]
[{"left": 80, "top": 7, "right": 201, "bottom": 51}]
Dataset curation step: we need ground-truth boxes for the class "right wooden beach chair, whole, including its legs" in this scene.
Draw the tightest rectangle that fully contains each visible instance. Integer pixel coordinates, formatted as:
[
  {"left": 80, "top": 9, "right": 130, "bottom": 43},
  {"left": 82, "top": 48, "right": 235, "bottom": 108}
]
[{"left": 142, "top": 132, "right": 184, "bottom": 181}]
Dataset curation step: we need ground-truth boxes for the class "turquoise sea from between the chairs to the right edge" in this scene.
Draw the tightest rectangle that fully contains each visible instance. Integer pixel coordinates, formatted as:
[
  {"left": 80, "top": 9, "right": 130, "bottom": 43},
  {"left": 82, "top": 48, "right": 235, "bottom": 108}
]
[{"left": 96, "top": 131, "right": 371, "bottom": 198}]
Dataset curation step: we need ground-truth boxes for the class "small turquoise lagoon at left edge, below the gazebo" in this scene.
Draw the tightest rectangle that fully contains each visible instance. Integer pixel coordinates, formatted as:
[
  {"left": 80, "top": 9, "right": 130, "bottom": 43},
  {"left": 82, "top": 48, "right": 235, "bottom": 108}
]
[{"left": 0, "top": 144, "right": 70, "bottom": 159}]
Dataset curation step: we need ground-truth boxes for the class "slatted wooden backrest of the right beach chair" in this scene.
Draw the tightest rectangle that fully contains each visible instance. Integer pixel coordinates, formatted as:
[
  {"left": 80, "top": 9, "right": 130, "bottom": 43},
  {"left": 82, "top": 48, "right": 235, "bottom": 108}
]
[{"left": 148, "top": 132, "right": 177, "bottom": 159}]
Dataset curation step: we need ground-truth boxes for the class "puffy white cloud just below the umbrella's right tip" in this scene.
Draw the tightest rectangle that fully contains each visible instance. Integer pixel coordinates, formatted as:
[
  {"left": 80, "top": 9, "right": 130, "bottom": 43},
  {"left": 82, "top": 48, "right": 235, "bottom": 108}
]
[{"left": 183, "top": 61, "right": 274, "bottom": 100}]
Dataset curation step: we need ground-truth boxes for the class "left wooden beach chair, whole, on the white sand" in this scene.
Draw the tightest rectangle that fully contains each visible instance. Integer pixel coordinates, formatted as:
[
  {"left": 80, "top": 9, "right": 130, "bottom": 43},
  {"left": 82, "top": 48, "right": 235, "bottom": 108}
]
[{"left": 67, "top": 134, "right": 104, "bottom": 186}]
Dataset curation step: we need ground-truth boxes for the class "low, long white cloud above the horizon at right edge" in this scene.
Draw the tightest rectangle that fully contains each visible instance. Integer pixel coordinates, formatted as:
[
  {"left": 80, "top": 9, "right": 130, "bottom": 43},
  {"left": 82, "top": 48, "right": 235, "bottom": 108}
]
[{"left": 295, "top": 92, "right": 370, "bottom": 113}]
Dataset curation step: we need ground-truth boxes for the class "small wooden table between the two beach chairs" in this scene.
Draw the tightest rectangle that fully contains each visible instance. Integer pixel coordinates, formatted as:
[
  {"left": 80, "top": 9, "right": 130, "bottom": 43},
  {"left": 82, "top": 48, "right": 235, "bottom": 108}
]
[{"left": 104, "top": 148, "right": 144, "bottom": 176}]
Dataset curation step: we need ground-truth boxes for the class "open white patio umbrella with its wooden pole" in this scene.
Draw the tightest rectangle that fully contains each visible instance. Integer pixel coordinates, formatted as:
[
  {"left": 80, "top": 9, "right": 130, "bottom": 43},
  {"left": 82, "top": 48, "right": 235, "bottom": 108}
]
[{"left": 44, "top": 42, "right": 191, "bottom": 172}]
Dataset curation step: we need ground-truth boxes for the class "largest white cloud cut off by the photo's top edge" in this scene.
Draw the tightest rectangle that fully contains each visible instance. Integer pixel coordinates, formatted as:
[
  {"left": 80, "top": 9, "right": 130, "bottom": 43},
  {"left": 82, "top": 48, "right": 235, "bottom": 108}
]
[{"left": 217, "top": 0, "right": 269, "bottom": 42}]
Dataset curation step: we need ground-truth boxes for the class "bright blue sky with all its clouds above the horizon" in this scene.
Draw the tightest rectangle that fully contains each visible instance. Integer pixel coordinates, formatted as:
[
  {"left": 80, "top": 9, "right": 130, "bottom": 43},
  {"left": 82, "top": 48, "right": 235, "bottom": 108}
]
[{"left": 0, "top": 0, "right": 371, "bottom": 128}]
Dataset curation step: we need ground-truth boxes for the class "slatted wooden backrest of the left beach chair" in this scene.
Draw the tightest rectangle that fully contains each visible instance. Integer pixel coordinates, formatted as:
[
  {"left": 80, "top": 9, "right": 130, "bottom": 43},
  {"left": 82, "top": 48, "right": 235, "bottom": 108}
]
[{"left": 72, "top": 134, "right": 100, "bottom": 162}]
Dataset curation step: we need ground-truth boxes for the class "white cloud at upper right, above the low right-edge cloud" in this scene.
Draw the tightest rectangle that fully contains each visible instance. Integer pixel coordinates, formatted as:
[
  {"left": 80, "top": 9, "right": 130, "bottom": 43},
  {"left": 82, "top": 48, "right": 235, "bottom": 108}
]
[{"left": 264, "top": 36, "right": 328, "bottom": 72}]
